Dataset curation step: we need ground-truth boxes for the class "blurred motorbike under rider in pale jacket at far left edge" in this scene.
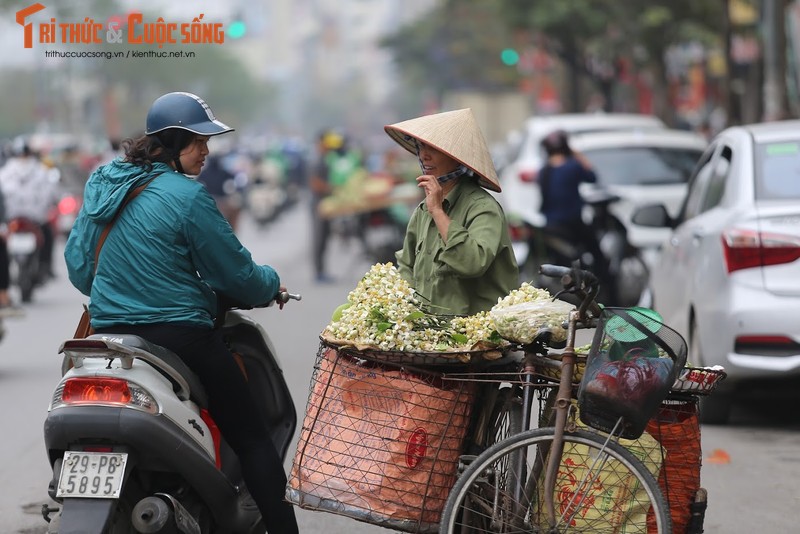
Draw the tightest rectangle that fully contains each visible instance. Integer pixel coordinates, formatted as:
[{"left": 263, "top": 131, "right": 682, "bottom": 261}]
[{"left": 6, "top": 217, "right": 47, "bottom": 302}]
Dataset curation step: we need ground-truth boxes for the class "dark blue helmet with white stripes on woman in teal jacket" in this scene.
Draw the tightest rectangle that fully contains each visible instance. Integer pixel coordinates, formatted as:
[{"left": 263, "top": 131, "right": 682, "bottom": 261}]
[{"left": 144, "top": 92, "right": 233, "bottom": 136}]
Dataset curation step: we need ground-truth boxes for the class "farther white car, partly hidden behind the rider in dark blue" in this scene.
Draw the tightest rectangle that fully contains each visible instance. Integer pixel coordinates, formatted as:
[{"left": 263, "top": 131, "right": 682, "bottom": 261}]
[{"left": 497, "top": 113, "right": 666, "bottom": 226}]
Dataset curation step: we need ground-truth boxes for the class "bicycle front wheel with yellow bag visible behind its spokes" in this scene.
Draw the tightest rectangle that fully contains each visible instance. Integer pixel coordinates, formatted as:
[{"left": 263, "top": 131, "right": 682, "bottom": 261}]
[{"left": 440, "top": 428, "right": 672, "bottom": 534}]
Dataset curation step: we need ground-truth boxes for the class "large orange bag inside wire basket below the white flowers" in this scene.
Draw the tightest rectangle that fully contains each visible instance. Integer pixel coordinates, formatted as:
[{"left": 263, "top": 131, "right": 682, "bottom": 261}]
[{"left": 286, "top": 343, "right": 475, "bottom": 532}]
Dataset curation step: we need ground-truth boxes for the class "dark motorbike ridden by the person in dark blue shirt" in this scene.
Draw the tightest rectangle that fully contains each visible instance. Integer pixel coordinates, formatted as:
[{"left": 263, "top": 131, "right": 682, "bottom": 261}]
[{"left": 509, "top": 188, "right": 649, "bottom": 306}]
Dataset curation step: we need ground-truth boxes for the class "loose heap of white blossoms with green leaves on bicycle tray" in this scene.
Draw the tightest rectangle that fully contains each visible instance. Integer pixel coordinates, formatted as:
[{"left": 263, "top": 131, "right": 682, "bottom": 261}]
[{"left": 323, "top": 263, "right": 564, "bottom": 352}]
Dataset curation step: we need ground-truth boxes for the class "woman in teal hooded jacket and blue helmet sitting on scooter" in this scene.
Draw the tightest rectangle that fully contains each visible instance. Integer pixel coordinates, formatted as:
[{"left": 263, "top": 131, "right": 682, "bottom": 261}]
[{"left": 64, "top": 92, "right": 298, "bottom": 534}]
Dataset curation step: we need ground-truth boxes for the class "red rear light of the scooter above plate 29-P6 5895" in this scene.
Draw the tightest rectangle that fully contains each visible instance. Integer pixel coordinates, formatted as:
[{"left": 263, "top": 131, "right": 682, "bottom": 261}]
[{"left": 52, "top": 377, "right": 159, "bottom": 413}]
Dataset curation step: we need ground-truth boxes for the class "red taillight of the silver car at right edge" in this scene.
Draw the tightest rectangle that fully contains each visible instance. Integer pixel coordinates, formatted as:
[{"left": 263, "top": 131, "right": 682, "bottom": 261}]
[{"left": 722, "top": 228, "right": 800, "bottom": 273}]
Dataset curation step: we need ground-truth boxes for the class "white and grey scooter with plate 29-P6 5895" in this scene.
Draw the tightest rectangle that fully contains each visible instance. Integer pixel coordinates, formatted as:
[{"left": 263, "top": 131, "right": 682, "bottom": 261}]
[{"left": 42, "top": 292, "right": 301, "bottom": 534}]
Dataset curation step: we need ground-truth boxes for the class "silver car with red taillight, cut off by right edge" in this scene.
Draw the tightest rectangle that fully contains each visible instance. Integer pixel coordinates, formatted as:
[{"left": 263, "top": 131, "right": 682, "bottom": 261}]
[{"left": 633, "top": 121, "right": 800, "bottom": 423}]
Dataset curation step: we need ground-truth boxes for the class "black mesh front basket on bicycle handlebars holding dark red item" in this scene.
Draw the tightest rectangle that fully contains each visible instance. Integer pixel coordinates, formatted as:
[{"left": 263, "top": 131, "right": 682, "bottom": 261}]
[{"left": 578, "top": 308, "right": 687, "bottom": 439}]
